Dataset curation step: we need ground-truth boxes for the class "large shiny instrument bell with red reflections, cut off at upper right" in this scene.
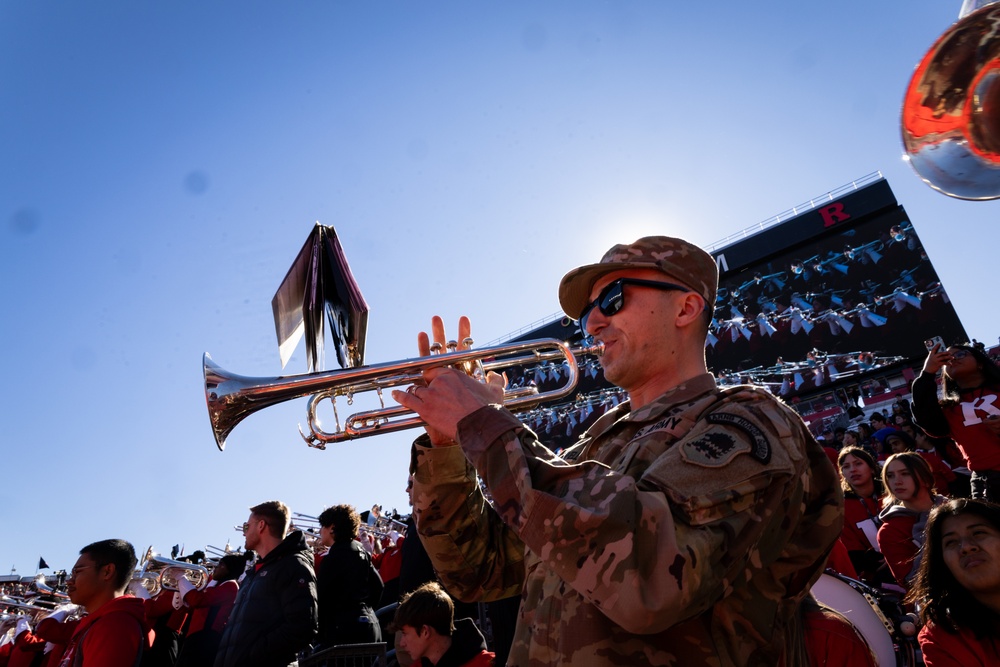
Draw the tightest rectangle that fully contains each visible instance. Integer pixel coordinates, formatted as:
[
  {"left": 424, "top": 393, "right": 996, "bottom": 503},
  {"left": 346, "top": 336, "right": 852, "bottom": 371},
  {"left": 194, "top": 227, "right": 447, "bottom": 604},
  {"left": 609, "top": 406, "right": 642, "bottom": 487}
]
[{"left": 902, "top": 2, "right": 1000, "bottom": 200}]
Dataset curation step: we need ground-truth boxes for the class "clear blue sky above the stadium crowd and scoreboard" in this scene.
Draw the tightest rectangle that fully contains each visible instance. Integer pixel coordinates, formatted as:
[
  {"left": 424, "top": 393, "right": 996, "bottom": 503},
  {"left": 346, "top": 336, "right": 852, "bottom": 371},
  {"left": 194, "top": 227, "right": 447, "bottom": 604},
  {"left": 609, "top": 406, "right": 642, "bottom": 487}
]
[{"left": 0, "top": 0, "right": 1000, "bottom": 574}]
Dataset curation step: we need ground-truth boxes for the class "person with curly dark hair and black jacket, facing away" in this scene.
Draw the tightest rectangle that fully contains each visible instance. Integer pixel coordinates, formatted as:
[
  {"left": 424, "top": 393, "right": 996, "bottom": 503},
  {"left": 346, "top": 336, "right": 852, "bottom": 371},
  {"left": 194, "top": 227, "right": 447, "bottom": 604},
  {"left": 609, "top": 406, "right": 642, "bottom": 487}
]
[{"left": 319, "top": 505, "right": 383, "bottom": 647}]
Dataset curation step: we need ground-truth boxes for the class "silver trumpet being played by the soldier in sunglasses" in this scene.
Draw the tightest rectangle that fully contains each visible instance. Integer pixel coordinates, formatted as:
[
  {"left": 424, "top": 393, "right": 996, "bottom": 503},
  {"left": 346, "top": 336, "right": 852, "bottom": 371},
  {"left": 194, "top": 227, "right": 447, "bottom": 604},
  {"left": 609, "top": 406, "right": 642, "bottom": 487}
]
[{"left": 204, "top": 338, "right": 604, "bottom": 450}]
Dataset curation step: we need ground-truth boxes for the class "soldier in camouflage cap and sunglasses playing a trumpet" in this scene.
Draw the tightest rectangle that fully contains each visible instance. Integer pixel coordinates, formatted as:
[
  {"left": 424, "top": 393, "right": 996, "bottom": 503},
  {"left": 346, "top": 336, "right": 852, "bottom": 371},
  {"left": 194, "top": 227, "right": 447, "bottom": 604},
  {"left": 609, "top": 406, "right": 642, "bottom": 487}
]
[{"left": 394, "top": 237, "right": 843, "bottom": 666}]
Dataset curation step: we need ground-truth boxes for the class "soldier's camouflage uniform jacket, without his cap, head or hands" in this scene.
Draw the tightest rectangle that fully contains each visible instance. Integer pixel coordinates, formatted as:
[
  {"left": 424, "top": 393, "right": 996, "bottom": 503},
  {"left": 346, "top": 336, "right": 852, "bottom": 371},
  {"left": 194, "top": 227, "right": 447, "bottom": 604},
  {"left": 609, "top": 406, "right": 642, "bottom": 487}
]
[{"left": 414, "top": 374, "right": 843, "bottom": 667}]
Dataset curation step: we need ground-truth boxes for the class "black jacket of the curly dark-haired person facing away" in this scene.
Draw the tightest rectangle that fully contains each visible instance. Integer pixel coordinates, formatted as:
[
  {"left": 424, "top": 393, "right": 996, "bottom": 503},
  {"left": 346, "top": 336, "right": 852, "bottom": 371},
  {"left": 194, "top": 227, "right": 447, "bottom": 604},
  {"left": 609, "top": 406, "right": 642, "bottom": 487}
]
[{"left": 317, "top": 540, "right": 383, "bottom": 646}]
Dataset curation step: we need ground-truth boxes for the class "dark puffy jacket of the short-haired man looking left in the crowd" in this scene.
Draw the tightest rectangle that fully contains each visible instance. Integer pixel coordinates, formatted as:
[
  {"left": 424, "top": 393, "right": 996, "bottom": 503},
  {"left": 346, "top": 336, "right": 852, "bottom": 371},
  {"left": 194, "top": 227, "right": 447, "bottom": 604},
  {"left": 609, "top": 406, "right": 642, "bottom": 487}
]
[{"left": 215, "top": 531, "right": 318, "bottom": 667}]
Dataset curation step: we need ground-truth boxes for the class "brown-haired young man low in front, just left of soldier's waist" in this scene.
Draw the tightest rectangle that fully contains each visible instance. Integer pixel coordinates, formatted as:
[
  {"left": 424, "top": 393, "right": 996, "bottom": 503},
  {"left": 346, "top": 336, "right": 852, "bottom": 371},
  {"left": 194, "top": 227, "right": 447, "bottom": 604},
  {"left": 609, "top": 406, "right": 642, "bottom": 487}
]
[{"left": 390, "top": 581, "right": 494, "bottom": 667}]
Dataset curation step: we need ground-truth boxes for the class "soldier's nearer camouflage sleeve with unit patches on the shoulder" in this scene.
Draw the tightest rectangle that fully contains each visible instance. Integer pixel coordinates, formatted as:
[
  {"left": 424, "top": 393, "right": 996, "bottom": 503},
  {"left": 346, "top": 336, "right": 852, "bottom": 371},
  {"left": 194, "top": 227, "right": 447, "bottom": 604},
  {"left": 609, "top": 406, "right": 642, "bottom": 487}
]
[{"left": 459, "top": 396, "right": 839, "bottom": 634}]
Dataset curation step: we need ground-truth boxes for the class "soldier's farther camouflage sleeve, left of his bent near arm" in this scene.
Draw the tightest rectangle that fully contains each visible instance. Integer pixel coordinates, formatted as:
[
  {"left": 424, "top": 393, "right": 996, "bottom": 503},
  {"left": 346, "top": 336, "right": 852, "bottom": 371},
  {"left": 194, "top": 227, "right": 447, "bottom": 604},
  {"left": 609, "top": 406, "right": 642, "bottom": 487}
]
[{"left": 413, "top": 438, "right": 524, "bottom": 602}]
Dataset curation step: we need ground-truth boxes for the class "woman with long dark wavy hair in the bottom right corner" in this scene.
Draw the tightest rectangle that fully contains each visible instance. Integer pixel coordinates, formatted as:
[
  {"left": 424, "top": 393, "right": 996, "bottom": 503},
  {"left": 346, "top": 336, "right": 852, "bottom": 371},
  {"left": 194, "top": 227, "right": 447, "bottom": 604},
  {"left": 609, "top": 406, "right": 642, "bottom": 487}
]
[{"left": 908, "top": 498, "right": 1000, "bottom": 667}]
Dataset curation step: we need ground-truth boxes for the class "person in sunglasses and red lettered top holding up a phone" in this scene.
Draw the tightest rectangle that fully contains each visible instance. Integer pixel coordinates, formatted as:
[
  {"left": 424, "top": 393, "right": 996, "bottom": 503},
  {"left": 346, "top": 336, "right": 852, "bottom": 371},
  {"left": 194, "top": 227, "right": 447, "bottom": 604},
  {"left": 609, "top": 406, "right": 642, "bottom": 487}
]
[{"left": 912, "top": 345, "right": 1000, "bottom": 502}]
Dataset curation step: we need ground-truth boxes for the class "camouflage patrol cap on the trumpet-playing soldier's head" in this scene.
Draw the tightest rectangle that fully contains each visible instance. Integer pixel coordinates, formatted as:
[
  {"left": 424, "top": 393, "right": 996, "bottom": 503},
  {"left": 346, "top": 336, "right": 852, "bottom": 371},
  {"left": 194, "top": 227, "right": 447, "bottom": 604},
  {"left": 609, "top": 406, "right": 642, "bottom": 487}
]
[{"left": 559, "top": 236, "right": 719, "bottom": 319}]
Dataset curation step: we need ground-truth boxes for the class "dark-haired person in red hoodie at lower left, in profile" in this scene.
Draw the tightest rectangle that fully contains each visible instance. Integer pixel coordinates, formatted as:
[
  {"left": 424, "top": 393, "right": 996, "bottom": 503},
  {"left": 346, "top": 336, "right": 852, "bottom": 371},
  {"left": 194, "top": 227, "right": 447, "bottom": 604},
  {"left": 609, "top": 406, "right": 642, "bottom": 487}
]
[{"left": 60, "top": 540, "right": 153, "bottom": 667}]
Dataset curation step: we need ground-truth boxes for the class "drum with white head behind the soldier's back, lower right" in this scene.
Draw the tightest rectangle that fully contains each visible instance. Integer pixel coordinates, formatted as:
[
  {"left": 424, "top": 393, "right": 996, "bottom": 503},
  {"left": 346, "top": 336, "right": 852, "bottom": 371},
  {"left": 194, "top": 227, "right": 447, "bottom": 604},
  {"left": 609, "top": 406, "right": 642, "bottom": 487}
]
[{"left": 812, "top": 572, "right": 917, "bottom": 667}]
